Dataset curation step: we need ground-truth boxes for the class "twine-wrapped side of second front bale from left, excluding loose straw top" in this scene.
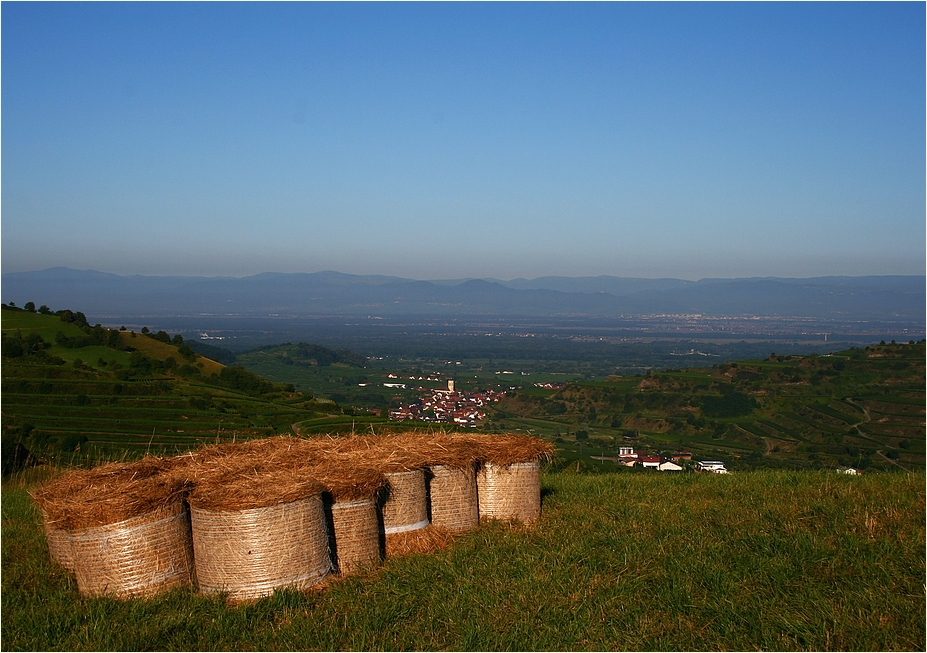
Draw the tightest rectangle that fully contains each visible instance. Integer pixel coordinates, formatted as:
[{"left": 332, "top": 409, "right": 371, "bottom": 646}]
[{"left": 190, "top": 494, "right": 331, "bottom": 601}]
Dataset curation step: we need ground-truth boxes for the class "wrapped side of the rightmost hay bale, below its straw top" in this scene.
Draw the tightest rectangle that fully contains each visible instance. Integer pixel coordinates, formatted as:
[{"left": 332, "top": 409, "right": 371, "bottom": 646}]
[{"left": 477, "top": 461, "right": 541, "bottom": 524}]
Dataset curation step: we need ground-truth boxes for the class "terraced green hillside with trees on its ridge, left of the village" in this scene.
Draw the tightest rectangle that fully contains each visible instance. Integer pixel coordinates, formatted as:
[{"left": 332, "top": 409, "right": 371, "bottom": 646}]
[{"left": 0, "top": 307, "right": 343, "bottom": 470}]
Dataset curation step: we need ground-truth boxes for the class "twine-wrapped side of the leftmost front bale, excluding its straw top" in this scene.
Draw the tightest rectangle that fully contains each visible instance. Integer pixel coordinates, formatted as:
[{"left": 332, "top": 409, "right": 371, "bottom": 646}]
[{"left": 68, "top": 497, "right": 193, "bottom": 598}]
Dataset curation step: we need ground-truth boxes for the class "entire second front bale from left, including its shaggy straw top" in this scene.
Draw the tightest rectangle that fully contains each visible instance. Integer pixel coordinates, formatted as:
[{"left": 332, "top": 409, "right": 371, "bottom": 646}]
[{"left": 189, "top": 466, "right": 331, "bottom": 601}]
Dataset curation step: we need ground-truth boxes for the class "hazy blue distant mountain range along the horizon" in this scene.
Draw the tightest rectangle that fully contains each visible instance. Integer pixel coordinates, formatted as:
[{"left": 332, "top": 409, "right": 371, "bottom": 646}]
[{"left": 0, "top": 267, "right": 927, "bottom": 323}]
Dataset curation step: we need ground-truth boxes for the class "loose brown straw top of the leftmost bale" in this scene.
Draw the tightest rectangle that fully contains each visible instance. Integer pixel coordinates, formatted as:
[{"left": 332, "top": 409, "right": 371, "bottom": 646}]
[{"left": 32, "top": 456, "right": 188, "bottom": 530}]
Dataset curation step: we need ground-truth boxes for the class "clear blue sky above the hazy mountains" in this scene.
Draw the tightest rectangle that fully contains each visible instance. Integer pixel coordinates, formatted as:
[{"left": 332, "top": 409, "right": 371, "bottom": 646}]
[{"left": 2, "top": 2, "right": 927, "bottom": 279}]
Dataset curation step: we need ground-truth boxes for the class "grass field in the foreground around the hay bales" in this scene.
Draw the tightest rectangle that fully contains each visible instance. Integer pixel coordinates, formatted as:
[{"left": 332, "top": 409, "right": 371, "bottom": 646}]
[{"left": 0, "top": 468, "right": 927, "bottom": 650}]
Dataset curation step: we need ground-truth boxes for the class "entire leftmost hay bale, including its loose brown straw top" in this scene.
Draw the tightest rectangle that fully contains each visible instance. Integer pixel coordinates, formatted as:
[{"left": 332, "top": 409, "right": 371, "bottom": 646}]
[{"left": 33, "top": 457, "right": 193, "bottom": 598}]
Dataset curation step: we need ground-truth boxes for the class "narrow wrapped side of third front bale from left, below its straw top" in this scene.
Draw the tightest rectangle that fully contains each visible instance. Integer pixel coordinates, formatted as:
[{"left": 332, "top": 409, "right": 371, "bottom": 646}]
[{"left": 331, "top": 497, "right": 381, "bottom": 574}]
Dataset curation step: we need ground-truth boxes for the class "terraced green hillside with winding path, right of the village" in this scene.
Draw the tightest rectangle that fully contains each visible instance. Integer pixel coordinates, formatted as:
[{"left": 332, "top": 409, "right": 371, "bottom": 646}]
[{"left": 495, "top": 342, "right": 925, "bottom": 470}]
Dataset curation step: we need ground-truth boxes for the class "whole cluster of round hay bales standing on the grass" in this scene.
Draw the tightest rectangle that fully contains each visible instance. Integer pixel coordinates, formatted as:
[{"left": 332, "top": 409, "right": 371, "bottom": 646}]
[{"left": 33, "top": 433, "right": 552, "bottom": 600}]
